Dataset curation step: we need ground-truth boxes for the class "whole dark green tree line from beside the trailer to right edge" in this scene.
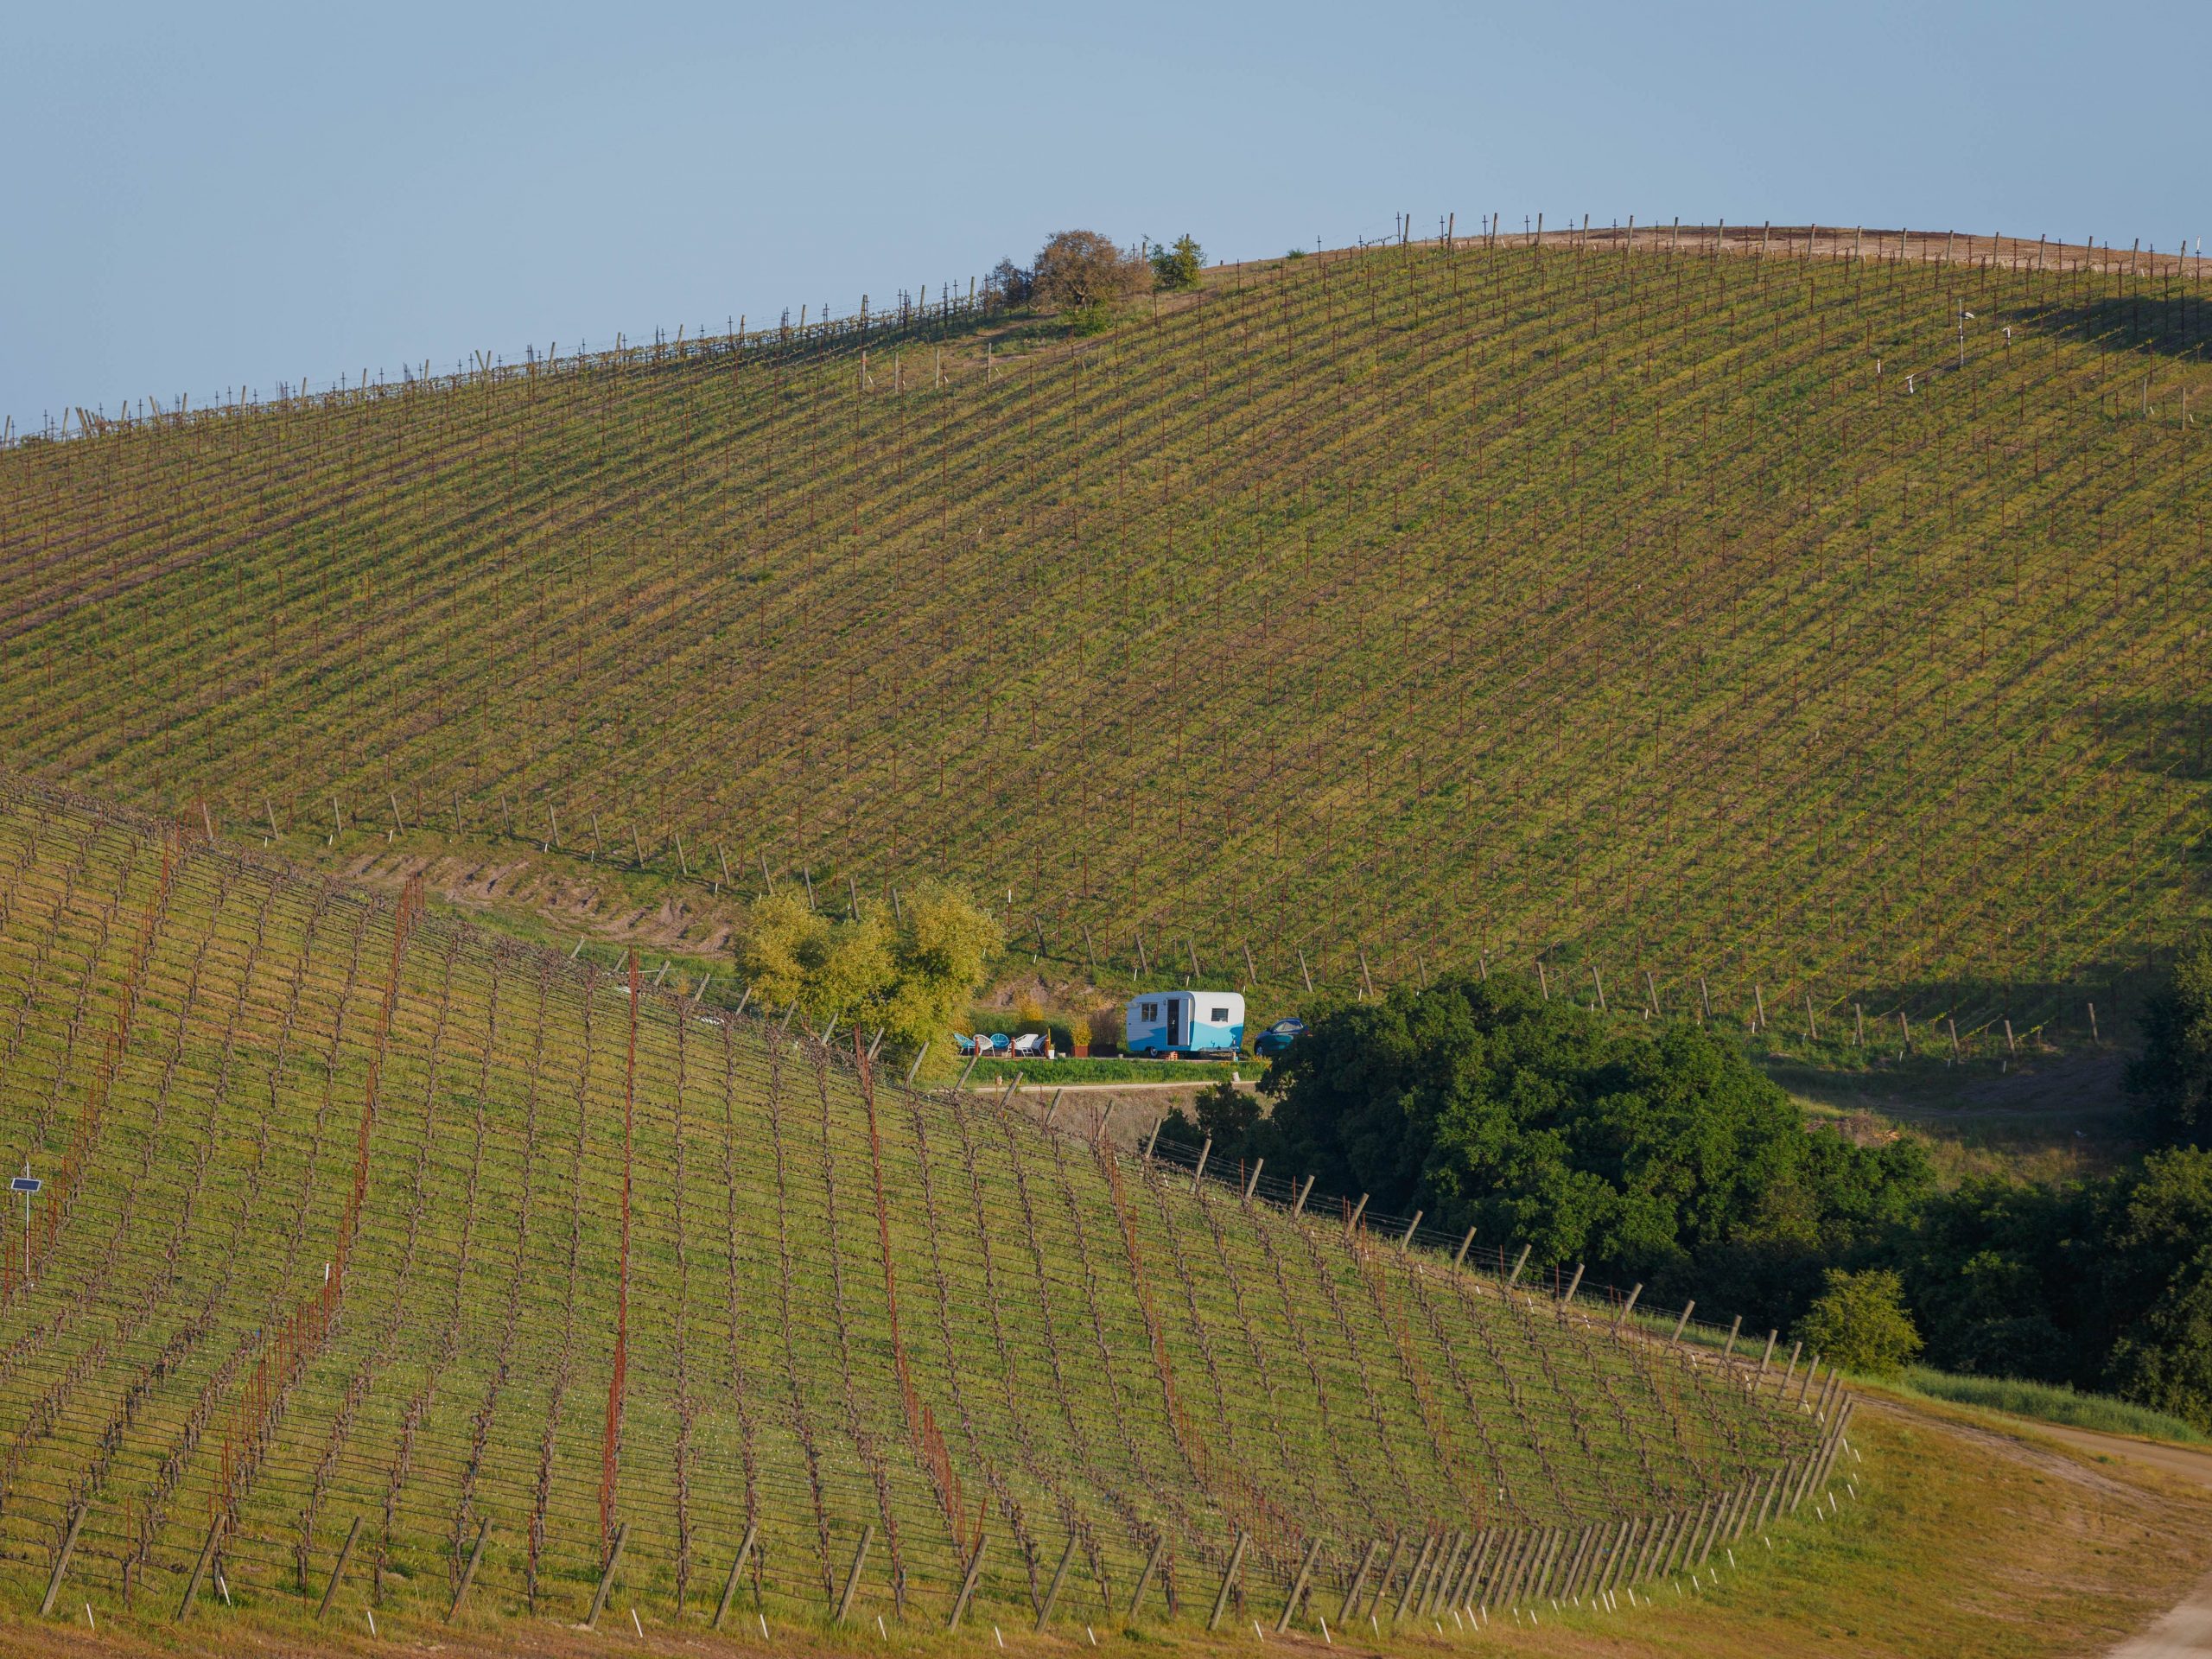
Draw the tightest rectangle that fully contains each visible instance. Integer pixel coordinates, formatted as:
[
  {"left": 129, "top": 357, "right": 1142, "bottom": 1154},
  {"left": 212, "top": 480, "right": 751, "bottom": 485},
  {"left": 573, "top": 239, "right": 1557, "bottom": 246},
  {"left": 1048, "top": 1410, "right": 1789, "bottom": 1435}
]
[{"left": 1166, "top": 940, "right": 2212, "bottom": 1427}]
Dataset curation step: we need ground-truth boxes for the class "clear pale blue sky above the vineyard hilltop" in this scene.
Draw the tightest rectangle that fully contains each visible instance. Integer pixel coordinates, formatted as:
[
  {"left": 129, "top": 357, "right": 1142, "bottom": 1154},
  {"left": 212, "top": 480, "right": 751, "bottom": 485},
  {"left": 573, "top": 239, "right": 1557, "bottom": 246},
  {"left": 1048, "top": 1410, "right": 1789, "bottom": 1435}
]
[{"left": 0, "top": 0, "right": 2212, "bottom": 429}]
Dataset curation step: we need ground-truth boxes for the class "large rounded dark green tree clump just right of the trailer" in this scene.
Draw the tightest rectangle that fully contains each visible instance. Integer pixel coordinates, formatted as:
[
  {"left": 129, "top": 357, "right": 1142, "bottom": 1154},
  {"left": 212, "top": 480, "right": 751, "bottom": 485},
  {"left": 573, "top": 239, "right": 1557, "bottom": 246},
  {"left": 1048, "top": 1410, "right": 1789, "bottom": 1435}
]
[{"left": 1256, "top": 976, "right": 1933, "bottom": 1307}]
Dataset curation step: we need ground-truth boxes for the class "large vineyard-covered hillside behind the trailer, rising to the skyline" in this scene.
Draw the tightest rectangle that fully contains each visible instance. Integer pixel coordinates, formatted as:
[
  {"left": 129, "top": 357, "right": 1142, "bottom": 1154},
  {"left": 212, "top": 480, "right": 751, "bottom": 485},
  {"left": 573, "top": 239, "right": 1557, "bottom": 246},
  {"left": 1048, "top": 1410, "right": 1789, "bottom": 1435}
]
[{"left": 0, "top": 230, "right": 2212, "bottom": 1027}]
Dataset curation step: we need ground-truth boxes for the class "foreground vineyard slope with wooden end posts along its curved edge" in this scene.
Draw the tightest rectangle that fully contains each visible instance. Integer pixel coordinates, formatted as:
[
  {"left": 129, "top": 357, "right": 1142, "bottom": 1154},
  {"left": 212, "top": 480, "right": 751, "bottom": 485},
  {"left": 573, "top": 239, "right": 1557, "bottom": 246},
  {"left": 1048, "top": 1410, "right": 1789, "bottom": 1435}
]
[{"left": 0, "top": 787, "right": 1847, "bottom": 1632}]
